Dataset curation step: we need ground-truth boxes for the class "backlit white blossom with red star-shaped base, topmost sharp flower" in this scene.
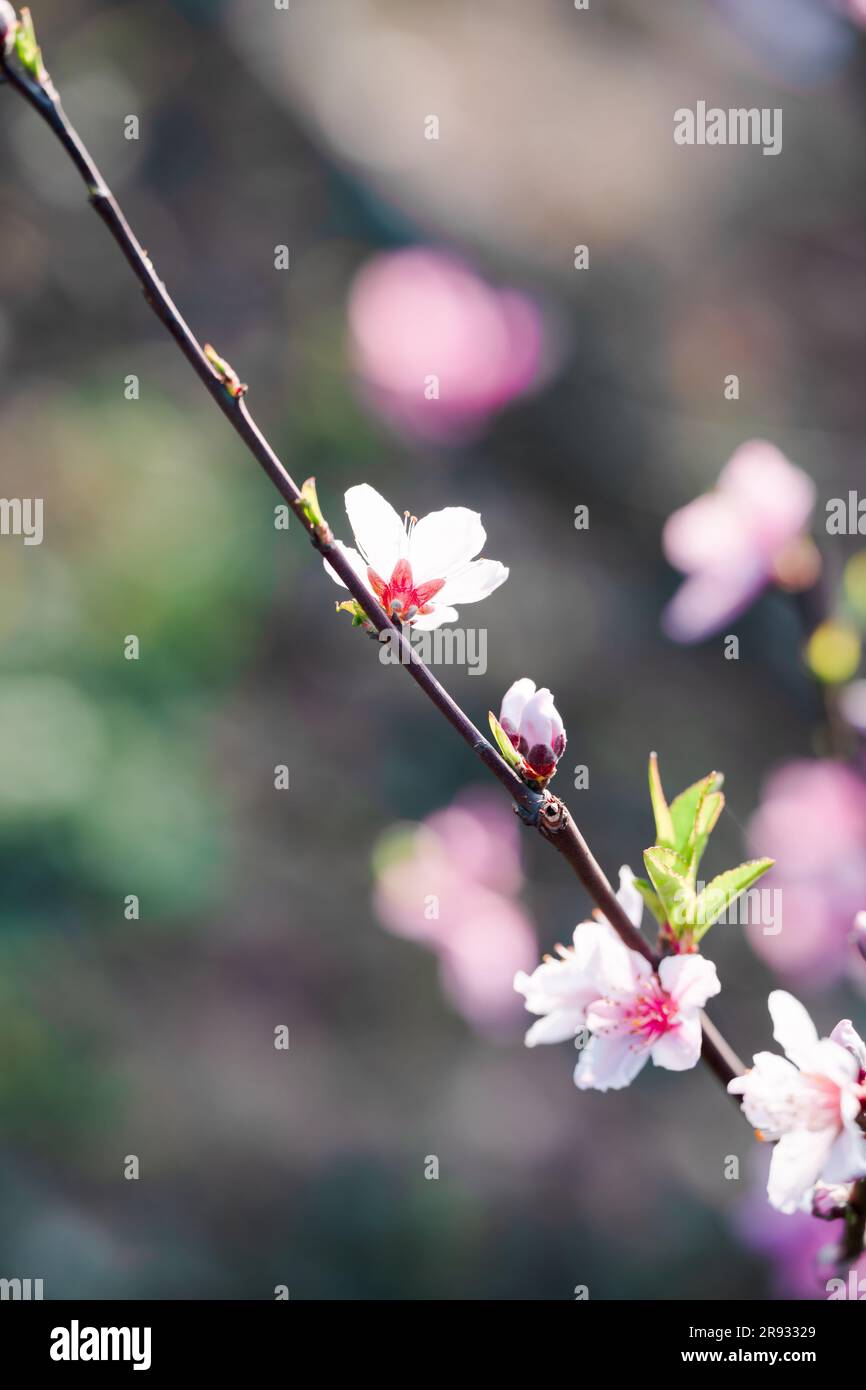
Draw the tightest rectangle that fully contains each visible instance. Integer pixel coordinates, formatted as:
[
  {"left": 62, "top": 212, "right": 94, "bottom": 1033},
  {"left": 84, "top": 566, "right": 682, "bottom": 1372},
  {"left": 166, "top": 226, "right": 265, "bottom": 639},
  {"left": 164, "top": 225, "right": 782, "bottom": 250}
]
[{"left": 324, "top": 482, "right": 509, "bottom": 630}]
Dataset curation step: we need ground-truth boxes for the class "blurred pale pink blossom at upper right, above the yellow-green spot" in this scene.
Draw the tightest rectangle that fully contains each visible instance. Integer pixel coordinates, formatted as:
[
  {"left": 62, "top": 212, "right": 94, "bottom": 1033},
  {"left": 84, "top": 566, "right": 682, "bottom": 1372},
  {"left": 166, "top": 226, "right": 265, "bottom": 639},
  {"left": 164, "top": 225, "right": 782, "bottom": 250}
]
[{"left": 662, "top": 439, "right": 820, "bottom": 642}]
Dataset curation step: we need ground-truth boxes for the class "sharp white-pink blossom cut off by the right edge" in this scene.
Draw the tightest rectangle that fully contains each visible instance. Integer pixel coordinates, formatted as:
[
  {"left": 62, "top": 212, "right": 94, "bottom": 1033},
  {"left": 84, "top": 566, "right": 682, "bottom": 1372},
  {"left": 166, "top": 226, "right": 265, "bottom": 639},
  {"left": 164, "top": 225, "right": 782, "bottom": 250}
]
[{"left": 728, "top": 990, "right": 866, "bottom": 1212}]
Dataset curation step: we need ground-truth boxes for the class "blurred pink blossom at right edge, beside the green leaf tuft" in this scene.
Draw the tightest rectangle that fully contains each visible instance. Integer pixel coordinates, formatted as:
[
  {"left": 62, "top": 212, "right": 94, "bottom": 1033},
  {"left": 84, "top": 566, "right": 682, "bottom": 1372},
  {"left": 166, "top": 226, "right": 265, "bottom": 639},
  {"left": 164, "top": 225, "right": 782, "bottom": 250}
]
[{"left": 746, "top": 759, "right": 866, "bottom": 986}]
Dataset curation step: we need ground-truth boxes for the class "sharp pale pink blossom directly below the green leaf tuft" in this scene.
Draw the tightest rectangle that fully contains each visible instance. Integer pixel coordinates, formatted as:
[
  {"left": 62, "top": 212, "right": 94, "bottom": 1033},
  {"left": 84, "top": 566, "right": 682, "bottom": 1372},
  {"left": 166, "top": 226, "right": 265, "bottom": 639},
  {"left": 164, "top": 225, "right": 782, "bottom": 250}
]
[{"left": 514, "top": 866, "right": 721, "bottom": 1091}]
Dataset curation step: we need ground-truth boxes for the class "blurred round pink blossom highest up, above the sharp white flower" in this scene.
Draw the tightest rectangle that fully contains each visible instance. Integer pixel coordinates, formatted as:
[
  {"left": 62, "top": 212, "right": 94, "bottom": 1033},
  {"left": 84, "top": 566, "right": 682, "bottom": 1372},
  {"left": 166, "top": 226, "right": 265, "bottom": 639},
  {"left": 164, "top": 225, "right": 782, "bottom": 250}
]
[{"left": 349, "top": 247, "right": 542, "bottom": 442}]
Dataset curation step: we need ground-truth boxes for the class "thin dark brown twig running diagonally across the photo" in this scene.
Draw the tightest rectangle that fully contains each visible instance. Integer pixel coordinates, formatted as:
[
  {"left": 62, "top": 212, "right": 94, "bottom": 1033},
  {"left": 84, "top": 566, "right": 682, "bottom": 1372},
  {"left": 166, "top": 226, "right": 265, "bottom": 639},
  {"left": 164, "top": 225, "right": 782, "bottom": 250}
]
[{"left": 0, "top": 29, "right": 744, "bottom": 1086}]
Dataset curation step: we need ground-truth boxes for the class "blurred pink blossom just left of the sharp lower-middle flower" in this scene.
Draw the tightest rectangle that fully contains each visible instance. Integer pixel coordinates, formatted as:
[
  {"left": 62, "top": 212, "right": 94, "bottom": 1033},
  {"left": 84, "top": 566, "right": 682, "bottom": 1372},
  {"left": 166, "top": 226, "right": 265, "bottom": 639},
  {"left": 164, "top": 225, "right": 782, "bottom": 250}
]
[{"left": 375, "top": 792, "right": 538, "bottom": 1036}]
